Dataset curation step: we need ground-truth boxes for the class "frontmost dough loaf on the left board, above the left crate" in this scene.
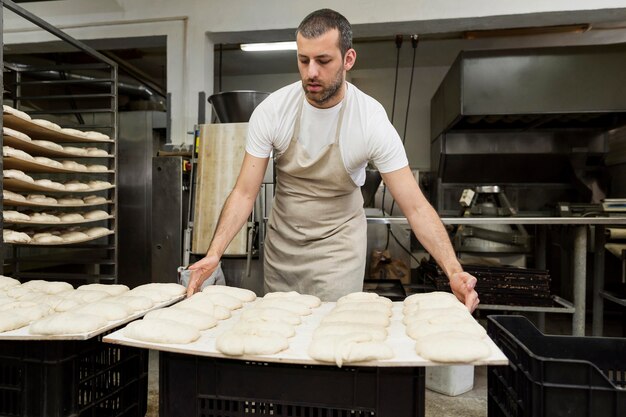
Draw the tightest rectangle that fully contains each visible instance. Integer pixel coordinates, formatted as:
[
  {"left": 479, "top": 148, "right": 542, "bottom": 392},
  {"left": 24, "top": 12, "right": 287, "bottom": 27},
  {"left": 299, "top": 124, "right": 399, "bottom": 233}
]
[{"left": 28, "top": 312, "right": 108, "bottom": 335}]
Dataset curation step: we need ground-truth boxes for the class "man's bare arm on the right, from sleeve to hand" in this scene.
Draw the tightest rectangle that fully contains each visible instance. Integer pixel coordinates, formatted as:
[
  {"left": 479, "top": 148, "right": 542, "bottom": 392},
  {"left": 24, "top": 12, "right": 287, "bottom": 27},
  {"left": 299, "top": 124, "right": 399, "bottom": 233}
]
[{"left": 381, "top": 166, "right": 479, "bottom": 311}]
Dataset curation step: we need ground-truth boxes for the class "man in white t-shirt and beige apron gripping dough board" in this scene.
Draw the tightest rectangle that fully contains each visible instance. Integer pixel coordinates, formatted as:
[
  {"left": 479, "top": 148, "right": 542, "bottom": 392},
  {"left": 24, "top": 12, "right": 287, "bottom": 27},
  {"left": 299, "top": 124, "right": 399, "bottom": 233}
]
[{"left": 188, "top": 9, "right": 478, "bottom": 311}]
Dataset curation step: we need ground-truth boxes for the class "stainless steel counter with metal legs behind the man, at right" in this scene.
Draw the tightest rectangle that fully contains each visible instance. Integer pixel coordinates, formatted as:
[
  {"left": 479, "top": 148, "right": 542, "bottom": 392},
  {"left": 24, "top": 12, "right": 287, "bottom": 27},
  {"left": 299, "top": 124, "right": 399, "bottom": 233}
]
[{"left": 367, "top": 216, "right": 626, "bottom": 336}]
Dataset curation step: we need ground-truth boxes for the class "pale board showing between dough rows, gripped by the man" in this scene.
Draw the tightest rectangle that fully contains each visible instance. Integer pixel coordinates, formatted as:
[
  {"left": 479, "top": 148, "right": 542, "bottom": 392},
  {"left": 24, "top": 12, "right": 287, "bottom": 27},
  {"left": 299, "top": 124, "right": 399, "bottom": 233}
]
[{"left": 102, "top": 300, "right": 508, "bottom": 367}]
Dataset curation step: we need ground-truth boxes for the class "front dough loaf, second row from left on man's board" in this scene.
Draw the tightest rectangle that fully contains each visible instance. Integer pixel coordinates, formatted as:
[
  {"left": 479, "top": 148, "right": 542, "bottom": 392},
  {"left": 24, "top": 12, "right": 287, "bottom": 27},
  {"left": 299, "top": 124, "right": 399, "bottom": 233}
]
[{"left": 215, "top": 329, "right": 289, "bottom": 356}]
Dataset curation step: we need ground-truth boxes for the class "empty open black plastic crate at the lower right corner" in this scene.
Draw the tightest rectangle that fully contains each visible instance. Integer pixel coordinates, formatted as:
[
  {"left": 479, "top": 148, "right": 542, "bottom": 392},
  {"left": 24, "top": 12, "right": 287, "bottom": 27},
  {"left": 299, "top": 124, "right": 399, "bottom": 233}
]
[{"left": 487, "top": 315, "right": 626, "bottom": 417}]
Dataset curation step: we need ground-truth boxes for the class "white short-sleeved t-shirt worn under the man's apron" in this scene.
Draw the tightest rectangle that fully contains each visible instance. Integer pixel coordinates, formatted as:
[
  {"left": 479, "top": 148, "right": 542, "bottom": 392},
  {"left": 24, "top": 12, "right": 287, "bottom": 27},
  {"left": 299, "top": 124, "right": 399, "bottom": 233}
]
[{"left": 246, "top": 81, "right": 408, "bottom": 186}]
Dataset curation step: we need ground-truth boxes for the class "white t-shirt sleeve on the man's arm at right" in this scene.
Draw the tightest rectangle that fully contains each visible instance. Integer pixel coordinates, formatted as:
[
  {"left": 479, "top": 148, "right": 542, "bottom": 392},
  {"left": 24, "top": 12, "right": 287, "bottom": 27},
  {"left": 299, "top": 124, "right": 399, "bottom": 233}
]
[{"left": 368, "top": 106, "right": 409, "bottom": 174}]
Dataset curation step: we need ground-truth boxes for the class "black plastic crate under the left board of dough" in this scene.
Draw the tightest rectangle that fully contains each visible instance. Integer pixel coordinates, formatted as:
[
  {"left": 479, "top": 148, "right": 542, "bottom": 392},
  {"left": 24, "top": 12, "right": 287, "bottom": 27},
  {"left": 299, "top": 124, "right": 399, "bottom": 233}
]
[{"left": 0, "top": 336, "right": 148, "bottom": 417}]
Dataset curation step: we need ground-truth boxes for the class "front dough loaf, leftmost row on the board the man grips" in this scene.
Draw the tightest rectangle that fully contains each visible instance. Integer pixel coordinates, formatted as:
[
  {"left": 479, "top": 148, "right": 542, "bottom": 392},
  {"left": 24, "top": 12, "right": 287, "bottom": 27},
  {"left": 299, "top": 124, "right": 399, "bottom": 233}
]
[{"left": 123, "top": 319, "right": 200, "bottom": 344}]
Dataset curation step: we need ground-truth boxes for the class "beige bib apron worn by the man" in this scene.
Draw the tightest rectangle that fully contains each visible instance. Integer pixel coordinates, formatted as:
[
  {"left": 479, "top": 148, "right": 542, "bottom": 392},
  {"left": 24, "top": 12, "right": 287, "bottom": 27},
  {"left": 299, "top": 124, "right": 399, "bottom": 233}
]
[{"left": 264, "top": 91, "right": 367, "bottom": 301}]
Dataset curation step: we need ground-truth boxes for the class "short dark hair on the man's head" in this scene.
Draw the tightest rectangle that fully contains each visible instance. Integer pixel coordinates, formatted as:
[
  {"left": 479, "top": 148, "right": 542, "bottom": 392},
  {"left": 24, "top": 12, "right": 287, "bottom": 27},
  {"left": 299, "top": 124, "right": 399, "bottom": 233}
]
[{"left": 296, "top": 9, "right": 352, "bottom": 56}]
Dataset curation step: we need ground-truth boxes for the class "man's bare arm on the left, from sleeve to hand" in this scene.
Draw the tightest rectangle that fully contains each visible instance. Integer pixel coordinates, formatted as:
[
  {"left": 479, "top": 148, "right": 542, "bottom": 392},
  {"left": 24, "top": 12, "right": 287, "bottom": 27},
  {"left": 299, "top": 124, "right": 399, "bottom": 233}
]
[{"left": 187, "top": 152, "right": 269, "bottom": 296}]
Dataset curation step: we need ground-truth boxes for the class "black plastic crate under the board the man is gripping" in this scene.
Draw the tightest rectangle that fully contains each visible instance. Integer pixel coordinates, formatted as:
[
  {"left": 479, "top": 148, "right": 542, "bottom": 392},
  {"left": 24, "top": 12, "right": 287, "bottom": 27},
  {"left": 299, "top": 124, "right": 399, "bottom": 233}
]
[{"left": 159, "top": 352, "right": 425, "bottom": 417}]
